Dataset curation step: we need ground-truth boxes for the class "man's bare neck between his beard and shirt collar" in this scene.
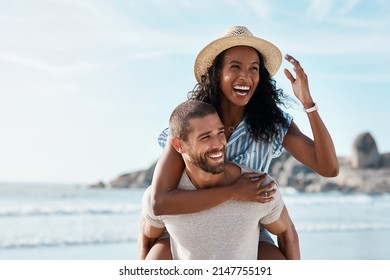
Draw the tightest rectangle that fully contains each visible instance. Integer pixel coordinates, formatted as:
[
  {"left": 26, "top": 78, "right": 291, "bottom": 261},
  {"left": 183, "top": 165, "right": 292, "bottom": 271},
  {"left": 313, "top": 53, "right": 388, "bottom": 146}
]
[{"left": 185, "top": 162, "right": 241, "bottom": 189}]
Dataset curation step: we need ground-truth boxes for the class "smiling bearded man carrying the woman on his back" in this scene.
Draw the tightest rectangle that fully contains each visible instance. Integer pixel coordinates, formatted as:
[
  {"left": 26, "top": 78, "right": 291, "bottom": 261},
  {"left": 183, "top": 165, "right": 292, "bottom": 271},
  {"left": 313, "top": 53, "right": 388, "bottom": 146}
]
[{"left": 139, "top": 100, "right": 300, "bottom": 260}]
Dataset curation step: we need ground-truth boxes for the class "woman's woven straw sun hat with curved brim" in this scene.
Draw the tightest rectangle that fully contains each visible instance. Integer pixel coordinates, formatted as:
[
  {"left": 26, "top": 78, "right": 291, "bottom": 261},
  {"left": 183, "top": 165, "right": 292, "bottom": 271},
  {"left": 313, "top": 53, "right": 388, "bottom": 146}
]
[{"left": 194, "top": 26, "right": 282, "bottom": 82}]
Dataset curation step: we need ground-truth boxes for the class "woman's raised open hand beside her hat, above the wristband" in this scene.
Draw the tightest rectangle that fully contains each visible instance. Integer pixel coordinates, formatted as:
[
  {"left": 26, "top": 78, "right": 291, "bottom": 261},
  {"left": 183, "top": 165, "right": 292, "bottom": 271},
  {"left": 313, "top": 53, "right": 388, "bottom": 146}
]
[{"left": 284, "top": 54, "right": 314, "bottom": 108}]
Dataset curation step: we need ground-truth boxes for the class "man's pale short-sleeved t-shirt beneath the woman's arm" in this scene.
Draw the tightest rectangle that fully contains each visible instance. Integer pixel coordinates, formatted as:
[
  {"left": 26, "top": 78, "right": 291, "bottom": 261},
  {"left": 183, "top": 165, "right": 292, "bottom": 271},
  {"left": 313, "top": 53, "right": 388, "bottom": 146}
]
[{"left": 142, "top": 165, "right": 284, "bottom": 260}]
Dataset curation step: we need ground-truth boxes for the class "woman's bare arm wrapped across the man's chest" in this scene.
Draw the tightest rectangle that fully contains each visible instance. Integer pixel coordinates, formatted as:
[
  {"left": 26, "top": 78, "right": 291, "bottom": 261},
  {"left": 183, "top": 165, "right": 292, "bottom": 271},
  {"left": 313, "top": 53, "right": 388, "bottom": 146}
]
[{"left": 151, "top": 141, "right": 273, "bottom": 215}]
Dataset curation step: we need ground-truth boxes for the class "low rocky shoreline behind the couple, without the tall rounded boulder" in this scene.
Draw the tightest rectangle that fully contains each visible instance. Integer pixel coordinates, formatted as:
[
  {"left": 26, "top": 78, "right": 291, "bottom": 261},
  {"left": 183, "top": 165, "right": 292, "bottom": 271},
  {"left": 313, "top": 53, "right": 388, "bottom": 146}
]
[{"left": 91, "top": 152, "right": 390, "bottom": 194}]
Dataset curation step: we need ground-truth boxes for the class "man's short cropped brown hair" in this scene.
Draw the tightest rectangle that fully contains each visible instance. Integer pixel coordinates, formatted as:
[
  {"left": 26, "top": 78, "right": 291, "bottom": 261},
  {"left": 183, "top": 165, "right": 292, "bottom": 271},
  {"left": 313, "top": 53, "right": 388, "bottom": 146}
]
[{"left": 169, "top": 99, "right": 217, "bottom": 141}]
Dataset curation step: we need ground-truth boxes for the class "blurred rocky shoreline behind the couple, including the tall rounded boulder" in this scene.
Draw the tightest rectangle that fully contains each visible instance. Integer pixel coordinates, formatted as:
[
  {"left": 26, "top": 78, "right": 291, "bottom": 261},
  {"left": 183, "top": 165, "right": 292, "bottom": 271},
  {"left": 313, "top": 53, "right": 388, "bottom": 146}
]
[{"left": 95, "top": 133, "right": 390, "bottom": 194}]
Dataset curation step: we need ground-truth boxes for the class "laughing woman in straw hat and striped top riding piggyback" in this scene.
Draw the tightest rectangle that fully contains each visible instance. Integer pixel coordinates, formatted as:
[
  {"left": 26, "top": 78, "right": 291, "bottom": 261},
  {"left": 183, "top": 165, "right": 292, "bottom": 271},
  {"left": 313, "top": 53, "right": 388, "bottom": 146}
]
[{"left": 145, "top": 26, "right": 339, "bottom": 259}]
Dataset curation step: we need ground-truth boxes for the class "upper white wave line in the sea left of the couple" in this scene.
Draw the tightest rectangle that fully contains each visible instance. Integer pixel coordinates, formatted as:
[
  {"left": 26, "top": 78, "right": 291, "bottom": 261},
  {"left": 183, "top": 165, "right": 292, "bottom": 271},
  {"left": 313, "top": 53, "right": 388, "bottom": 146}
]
[{"left": 0, "top": 204, "right": 141, "bottom": 217}]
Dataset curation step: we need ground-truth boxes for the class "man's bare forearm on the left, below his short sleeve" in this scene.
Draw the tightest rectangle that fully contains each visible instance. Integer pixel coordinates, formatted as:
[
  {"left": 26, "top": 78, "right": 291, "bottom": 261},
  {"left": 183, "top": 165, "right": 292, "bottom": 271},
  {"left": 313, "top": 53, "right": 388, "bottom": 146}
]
[{"left": 138, "top": 217, "right": 165, "bottom": 260}]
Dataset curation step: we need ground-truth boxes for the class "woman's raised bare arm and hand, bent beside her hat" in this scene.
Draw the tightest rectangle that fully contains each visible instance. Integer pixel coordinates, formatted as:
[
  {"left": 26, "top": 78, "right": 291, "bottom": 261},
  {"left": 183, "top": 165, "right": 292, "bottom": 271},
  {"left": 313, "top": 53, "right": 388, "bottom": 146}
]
[{"left": 283, "top": 55, "right": 339, "bottom": 177}]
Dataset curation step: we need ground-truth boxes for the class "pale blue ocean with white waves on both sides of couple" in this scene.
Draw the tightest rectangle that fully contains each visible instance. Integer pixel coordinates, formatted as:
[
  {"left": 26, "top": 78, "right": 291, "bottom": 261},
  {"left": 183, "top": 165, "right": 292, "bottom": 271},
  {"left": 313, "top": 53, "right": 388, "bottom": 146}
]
[{"left": 0, "top": 183, "right": 390, "bottom": 260}]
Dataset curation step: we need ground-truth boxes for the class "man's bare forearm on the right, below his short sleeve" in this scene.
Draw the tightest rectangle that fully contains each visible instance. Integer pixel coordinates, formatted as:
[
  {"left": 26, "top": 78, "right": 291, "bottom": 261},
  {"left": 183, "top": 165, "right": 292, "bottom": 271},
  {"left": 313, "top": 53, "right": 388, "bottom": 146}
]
[{"left": 264, "top": 206, "right": 301, "bottom": 260}]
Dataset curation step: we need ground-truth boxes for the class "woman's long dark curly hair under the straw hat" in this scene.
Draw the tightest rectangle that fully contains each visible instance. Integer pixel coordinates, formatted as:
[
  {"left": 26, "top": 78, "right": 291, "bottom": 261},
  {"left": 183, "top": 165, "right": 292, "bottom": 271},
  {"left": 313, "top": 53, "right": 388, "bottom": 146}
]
[{"left": 188, "top": 47, "right": 288, "bottom": 142}]
